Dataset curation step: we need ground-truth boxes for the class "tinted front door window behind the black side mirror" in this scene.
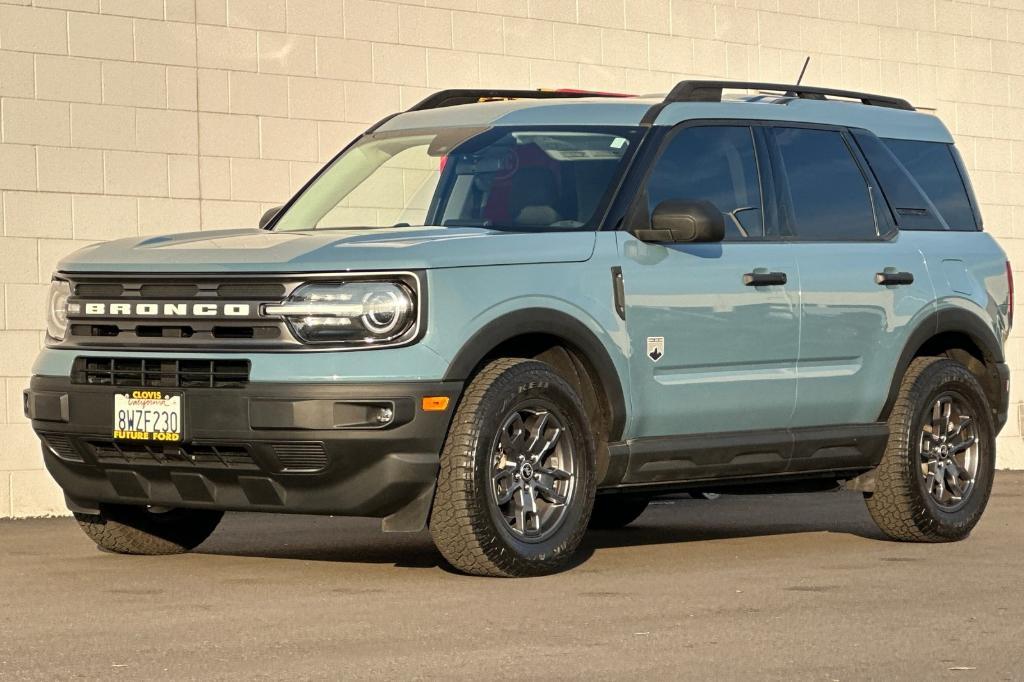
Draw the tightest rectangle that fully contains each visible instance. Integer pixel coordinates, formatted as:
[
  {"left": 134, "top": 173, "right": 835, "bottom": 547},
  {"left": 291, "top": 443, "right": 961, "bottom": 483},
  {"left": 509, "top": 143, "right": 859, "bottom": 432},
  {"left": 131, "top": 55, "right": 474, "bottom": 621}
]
[{"left": 647, "top": 126, "right": 765, "bottom": 240}]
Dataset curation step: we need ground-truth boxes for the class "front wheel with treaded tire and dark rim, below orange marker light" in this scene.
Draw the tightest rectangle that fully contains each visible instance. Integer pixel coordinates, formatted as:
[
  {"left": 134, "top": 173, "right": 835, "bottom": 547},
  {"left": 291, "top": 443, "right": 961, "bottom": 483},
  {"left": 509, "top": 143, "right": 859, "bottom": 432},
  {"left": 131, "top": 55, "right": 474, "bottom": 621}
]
[{"left": 430, "top": 358, "right": 597, "bottom": 578}]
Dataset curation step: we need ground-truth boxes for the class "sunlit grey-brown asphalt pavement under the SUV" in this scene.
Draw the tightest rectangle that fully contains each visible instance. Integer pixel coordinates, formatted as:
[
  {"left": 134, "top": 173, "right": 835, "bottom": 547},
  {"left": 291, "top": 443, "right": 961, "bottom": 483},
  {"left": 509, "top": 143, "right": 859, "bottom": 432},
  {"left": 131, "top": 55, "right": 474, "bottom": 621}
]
[{"left": 0, "top": 472, "right": 1024, "bottom": 680}]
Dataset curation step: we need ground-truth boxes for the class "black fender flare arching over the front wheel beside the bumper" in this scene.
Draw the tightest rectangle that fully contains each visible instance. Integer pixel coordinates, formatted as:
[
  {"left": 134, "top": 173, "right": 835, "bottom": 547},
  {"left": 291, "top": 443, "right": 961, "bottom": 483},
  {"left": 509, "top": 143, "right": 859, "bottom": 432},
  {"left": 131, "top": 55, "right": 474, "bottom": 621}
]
[{"left": 444, "top": 308, "right": 626, "bottom": 441}]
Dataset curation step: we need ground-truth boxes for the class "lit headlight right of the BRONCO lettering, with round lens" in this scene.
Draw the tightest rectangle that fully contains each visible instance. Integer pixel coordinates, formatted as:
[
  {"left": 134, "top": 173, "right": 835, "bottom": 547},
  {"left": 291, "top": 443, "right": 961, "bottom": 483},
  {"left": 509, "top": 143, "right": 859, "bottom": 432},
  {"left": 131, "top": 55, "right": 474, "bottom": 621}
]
[{"left": 265, "top": 282, "right": 417, "bottom": 346}]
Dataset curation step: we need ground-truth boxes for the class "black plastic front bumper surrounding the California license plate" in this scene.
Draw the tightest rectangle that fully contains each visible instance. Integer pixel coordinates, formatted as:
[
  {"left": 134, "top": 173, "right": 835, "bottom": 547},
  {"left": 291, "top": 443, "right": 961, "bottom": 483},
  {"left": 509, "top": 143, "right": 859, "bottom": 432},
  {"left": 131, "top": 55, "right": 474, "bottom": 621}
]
[{"left": 25, "top": 376, "right": 462, "bottom": 530}]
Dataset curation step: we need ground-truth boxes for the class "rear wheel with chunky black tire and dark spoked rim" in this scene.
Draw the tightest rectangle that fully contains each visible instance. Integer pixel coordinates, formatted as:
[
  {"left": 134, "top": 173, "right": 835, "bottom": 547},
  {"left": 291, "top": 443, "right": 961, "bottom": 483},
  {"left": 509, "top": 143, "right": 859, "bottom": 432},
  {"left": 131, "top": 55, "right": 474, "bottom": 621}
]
[{"left": 864, "top": 357, "right": 995, "bottom": 543}]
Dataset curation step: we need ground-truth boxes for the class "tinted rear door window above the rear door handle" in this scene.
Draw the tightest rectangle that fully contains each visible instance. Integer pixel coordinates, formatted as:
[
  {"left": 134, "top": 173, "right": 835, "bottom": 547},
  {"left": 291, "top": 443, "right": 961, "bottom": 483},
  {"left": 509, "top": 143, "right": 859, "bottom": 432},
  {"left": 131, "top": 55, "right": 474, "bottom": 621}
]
[{"left": 772, "top": 128, "right": 878, "bottom": 242}]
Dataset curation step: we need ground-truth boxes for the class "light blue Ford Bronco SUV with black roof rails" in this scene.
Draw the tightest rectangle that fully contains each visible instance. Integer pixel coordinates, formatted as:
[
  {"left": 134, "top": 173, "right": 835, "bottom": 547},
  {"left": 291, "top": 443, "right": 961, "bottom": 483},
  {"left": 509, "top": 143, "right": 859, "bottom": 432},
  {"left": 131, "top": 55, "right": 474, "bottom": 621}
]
[{"left": 25, "top": 81, "right": 1013, "bottom": 576}]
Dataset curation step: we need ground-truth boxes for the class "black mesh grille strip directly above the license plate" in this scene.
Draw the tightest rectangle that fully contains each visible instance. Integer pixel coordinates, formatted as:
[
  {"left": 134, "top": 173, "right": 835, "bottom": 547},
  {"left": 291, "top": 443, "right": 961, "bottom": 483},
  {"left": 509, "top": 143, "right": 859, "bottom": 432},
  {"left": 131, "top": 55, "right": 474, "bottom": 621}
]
[{"left": 72, "top": 357, "right": 249, "bottom": 388}]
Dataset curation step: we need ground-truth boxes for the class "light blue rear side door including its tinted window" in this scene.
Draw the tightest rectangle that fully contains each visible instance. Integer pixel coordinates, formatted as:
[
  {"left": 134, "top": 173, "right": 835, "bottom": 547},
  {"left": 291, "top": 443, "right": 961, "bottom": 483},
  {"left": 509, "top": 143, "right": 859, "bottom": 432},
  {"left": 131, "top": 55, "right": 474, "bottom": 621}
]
[{"left": 768, "top": 125, "right": 934, "bottom": 438}]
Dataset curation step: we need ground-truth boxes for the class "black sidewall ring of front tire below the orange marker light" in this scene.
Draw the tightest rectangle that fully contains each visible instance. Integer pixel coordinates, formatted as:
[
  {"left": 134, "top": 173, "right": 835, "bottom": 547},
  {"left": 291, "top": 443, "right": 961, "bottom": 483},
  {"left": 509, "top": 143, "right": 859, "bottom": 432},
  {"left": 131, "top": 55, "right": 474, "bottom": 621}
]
[{"left": 473, "top": 363, "right": 596, "bottom": 572}]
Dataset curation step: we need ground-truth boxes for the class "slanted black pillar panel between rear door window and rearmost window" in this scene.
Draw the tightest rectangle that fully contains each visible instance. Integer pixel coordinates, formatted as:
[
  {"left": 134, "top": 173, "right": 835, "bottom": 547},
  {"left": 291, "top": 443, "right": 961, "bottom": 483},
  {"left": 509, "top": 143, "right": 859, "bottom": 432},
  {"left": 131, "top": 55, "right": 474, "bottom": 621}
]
[{"left": 853, "top": 132, "right": 946, "bottom": 229}]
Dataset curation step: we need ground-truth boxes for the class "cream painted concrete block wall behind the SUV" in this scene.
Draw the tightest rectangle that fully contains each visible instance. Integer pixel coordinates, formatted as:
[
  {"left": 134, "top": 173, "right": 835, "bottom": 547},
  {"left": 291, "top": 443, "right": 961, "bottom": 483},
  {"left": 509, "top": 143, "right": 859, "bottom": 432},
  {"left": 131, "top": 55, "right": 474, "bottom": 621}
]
[{"left": 0, "top": 0, "right": 1024, "bottom": 517}]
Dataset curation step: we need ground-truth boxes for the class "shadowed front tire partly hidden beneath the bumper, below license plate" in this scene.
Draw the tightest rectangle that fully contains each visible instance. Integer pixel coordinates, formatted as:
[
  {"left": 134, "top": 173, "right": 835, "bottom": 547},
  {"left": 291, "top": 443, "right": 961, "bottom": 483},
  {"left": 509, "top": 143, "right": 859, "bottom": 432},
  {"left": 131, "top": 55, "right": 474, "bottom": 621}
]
[{"left": 75, "top": 505, "right": 224, "bottom": 555}]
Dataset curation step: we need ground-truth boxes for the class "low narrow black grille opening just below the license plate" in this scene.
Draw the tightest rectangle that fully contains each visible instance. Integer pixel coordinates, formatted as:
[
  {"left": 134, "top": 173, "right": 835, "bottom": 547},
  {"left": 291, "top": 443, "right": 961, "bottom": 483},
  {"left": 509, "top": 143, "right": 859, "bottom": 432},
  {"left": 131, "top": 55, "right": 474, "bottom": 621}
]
[{"left": 85, "top": 439, "right": 259, "bottom": 471}]
